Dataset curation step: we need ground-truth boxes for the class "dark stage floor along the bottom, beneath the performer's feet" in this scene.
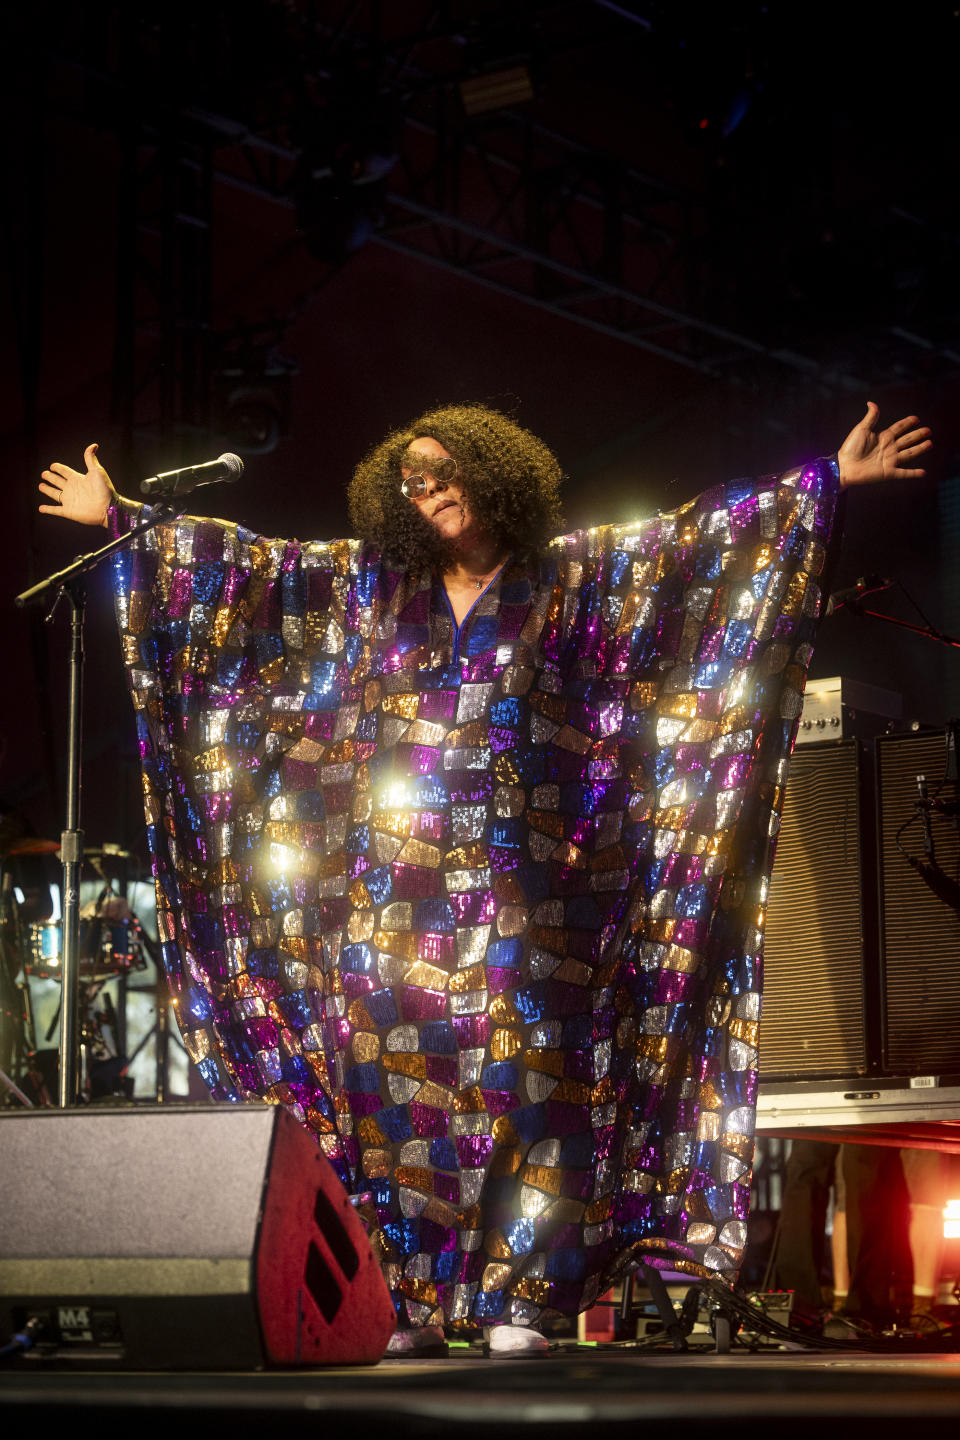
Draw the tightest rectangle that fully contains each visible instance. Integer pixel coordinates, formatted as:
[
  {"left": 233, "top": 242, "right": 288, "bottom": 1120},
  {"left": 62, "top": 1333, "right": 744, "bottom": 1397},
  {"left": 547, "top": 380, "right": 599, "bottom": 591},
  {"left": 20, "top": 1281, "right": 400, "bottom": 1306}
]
[{"left": 0, "top": 1348, "right": 960, "bottom": 1440}]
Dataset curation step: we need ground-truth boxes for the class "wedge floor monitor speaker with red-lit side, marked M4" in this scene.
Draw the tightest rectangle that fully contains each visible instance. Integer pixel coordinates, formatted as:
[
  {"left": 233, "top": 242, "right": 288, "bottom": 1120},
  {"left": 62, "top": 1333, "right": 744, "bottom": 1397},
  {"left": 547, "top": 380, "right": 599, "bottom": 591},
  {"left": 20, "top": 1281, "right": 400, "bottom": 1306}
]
[{"left": 0, "top": 1106, "right": 394, "bottom": 1369}]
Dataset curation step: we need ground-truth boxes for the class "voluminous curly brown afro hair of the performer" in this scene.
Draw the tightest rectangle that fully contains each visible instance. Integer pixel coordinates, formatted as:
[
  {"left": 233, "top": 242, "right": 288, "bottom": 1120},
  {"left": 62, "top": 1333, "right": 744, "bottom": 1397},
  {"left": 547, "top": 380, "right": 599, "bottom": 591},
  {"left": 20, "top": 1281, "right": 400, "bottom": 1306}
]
[{"left": 347, "top": 405, "right": 563, "bottom": 573}]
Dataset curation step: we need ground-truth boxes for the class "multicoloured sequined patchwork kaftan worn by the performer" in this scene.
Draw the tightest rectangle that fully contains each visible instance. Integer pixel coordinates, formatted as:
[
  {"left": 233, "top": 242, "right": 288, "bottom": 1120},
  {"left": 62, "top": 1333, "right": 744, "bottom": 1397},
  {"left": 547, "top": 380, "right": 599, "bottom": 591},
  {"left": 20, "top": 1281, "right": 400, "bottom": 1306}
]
[{"left": 115, "top": 461, "right": 838, "bottom": 1325}]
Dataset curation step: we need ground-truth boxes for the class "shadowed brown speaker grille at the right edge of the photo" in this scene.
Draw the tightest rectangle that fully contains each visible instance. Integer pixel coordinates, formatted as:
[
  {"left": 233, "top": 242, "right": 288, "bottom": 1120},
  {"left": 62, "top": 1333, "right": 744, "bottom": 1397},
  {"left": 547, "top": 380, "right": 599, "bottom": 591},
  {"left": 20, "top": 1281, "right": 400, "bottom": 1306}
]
[{"left": 877, "top": 732, "right": 960, "bottom": 1074}]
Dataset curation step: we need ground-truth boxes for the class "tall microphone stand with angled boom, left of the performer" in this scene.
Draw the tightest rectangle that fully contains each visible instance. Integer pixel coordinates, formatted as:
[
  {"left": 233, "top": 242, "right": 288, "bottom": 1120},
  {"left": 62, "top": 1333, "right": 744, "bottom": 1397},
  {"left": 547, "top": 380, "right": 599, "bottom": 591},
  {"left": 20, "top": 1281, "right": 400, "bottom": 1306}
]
[{"left": 14, "top": 501, "right": 186, "bottom": 1109}]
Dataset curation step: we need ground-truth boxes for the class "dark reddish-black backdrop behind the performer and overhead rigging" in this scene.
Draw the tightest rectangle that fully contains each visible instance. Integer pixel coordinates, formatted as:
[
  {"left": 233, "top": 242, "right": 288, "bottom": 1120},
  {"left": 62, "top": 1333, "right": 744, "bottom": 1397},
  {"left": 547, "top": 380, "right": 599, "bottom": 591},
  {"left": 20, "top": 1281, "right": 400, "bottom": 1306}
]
[{"left": 0, "top": 0, "right": 960, "bottom": 848}]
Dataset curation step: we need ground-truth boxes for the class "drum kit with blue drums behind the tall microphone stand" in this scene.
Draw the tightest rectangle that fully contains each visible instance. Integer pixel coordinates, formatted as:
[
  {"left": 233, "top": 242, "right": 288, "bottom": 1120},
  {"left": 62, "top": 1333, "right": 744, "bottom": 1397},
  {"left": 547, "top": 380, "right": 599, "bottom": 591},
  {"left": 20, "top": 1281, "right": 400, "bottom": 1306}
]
[{"left": 0, "top": 837, "right": 154, "bottom": 1106}]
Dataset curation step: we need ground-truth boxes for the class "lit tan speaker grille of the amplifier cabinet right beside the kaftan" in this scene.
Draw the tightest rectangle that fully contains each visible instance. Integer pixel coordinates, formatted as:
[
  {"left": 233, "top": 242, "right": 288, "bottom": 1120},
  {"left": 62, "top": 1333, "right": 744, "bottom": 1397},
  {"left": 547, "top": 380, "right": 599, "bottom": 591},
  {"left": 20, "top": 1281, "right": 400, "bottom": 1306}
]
[{"left": 760, "top": 740, "right": 866, "bottom": 1079}]
